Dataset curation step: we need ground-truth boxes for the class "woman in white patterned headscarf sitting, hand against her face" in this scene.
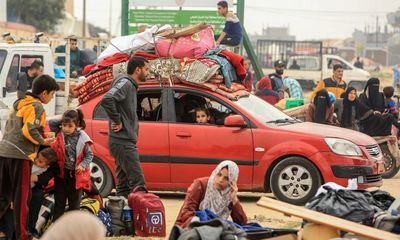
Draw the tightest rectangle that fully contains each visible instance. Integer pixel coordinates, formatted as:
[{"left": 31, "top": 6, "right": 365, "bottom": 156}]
[{"left": 175, "top": 160, "right": 247, "bottom": 228}]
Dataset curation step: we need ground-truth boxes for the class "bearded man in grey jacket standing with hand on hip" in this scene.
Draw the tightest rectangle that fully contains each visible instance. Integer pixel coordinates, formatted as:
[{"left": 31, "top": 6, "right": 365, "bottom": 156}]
[{"left": 101, "top": 57, "right": 149, "bottom": 197}]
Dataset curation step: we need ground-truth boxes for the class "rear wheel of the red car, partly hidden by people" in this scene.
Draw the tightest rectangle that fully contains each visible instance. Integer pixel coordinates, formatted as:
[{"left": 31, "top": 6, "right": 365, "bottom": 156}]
[{"left": 90, "top": 157, "right": 114, "bottom": 197}]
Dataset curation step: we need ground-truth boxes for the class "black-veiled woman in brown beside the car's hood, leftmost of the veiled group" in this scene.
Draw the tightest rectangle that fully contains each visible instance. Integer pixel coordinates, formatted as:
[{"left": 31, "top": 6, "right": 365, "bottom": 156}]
[{"left": 306, "top": 88, "right": 335, "bottom": 125}]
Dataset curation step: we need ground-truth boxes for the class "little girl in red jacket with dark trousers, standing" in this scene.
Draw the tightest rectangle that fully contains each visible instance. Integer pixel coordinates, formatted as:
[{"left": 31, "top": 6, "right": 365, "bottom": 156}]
[{"left": 49, "top": 109, "right": 93, "bottom": 220}]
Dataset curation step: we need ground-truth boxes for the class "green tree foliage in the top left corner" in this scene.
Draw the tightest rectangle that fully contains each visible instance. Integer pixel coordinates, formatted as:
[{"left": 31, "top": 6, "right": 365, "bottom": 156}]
[{"left": 7, "top": 0, "right": 65, "bottom": 32}]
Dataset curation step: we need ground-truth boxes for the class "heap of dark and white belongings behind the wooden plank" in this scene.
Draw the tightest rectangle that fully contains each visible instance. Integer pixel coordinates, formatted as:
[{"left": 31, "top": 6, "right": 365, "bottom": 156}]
[{"left": 306, "top": 183, "right": 400, "bottom": 234}]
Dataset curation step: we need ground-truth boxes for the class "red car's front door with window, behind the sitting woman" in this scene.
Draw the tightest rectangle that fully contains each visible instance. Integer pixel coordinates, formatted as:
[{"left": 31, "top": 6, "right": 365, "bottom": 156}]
[{"left": 169, "top": 89, "right": 253, "bottom": 189}]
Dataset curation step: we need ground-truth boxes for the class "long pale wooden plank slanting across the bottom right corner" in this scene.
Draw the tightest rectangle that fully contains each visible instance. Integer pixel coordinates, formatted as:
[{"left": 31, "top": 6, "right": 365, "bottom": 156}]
[{"left": 257, "top": 197, "right": 400, "bottom": 240}]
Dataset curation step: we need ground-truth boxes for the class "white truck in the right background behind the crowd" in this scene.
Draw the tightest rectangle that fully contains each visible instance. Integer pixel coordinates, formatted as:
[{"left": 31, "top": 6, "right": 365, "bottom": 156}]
[{"left": 256, "top": 40, "right": 370, "bottom": 90}]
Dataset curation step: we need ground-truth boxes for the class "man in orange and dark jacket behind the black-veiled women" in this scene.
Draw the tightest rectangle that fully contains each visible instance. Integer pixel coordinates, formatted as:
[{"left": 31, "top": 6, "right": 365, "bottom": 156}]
[{"left": 311, "top": 64, "right": 347, "bottom": 101}]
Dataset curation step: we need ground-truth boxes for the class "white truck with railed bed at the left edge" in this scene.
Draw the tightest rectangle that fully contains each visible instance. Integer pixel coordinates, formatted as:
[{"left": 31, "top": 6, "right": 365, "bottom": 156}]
[{"left": 0, "top": 38, "right": 107, "bottom": 123}]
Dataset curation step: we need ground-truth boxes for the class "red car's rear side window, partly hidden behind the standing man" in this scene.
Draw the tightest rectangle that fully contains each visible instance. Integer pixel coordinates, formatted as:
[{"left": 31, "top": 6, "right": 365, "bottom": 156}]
[{"left": 93, "top": 90, "right": 162, "bottom": 122}]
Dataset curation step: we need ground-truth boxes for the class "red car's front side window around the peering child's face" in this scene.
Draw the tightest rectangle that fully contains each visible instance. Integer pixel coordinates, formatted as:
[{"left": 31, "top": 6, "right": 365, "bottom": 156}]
[{"left": 174, "top": 91, "right": 233, "bottom": 125}]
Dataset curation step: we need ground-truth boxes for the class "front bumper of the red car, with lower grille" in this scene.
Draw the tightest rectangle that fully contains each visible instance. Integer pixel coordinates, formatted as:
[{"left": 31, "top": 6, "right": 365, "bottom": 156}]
[{"left": 311, "top": 152, "right": 384, "bottom": 189}]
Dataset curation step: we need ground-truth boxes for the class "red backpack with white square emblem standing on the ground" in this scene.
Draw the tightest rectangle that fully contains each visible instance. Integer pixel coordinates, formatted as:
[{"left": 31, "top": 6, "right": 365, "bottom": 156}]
[{"left": 128, "top": 186, "right": 166, "bottom": 237}]
